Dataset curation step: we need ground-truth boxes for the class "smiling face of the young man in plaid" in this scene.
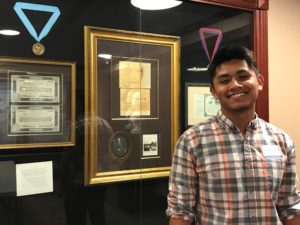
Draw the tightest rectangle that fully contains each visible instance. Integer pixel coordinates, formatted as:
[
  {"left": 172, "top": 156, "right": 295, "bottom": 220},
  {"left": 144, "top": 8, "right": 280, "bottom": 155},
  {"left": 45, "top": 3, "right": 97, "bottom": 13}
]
[{"left": 211, "top": 59, "right": 263, "bottom": 115}]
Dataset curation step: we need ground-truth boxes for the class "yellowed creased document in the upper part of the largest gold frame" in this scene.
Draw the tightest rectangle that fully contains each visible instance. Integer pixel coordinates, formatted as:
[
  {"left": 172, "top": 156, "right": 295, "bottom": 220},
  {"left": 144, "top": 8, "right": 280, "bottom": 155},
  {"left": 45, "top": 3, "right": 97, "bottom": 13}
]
[{"left": 111, "top": 56, "right": 159, "bottom": 120}]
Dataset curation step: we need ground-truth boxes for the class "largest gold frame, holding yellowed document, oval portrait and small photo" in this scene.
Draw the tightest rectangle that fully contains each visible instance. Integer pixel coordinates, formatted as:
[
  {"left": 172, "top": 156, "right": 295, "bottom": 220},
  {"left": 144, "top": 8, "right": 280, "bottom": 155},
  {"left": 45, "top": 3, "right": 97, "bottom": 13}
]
[{"left": 84, "top": 27, "right": 180, "bottom": 185}]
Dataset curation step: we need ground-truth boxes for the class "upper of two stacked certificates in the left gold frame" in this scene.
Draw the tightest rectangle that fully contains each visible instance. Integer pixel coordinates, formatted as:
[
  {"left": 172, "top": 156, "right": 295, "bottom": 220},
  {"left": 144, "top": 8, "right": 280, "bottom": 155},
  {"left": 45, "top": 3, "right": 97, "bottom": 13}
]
[{"left": 9, "top": 71, "right": 61, "bottom": 103}]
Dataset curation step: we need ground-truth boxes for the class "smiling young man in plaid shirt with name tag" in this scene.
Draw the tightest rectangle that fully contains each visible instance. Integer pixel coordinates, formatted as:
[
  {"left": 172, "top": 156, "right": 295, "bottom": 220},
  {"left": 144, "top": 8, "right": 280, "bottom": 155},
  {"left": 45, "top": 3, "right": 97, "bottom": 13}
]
[{"left": 167, "top": 45, "right": 300, "bottom": 225}]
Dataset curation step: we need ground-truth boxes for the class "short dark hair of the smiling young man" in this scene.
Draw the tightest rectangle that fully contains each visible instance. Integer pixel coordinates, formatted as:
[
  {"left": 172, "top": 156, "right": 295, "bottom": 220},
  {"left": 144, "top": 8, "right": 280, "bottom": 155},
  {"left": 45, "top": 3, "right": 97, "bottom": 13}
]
[{"left": 208, "top": 44, "right": 259, "bottom": 86}]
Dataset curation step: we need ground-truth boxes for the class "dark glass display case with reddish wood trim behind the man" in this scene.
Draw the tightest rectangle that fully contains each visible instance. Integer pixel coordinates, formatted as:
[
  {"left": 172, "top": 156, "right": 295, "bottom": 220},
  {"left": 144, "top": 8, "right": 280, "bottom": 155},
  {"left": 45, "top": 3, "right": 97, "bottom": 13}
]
[{"left": 0, "top": 0, "right": 268, "bottom": 225}]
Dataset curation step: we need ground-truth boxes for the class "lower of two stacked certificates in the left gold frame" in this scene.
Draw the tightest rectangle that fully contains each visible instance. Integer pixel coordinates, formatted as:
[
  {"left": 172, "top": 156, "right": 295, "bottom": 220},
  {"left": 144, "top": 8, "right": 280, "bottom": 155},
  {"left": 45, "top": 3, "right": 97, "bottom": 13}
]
[{"left": 9, "top": 105, "right": 60, "bottom": 135}]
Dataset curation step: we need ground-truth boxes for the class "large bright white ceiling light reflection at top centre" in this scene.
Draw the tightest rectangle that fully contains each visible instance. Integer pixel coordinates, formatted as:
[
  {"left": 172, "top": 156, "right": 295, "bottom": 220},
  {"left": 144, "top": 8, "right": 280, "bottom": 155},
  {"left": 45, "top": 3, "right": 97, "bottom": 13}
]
[{"left": 131, "top": 0, "right": 182, "bottom": 10}]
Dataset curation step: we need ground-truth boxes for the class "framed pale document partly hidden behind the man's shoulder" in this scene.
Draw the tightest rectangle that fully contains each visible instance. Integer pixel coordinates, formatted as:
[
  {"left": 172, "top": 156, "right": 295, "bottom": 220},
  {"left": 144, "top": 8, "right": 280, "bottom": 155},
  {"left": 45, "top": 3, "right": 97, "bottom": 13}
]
[{"left": 185, "top": 82, "right": 220, "bottom": 128}]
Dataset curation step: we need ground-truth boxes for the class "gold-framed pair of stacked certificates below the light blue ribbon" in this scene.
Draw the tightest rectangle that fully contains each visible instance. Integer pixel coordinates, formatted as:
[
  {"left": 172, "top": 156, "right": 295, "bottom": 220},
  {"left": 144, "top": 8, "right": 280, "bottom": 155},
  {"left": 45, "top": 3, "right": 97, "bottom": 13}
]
[{"left": 0, "top": 58, "right": 75, "bottom": 149}]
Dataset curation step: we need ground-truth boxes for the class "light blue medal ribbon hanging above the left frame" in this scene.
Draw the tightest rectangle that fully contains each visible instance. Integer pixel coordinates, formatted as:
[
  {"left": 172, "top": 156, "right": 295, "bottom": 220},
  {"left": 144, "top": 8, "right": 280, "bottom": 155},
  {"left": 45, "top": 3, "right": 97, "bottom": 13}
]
[{"left": 14, "top": 2, "right": 60, "bottom": 42}]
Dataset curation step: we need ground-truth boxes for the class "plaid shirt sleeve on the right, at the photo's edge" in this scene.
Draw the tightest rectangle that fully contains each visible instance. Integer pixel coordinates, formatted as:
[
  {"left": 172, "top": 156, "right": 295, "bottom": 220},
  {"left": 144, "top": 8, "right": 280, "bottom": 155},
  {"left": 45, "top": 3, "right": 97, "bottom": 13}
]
[{"left": 277, "top": 140, "right": 300, "bottom": 220}]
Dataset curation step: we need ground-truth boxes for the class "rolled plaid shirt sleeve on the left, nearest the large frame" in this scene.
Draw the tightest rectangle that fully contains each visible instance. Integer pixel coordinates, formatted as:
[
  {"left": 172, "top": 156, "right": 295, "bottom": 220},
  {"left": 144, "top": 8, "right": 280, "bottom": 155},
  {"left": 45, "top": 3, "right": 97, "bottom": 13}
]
[{"left": 166, "top": 133, "right": 198, "bottom": 221}]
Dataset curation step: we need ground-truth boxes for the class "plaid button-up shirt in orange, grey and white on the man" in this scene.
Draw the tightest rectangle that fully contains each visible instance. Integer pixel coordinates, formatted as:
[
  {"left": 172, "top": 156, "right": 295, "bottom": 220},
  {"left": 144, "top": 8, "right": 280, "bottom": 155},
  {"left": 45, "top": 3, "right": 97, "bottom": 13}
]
[{"left": 166, "top": 111, "right": 300, "bottom": 225}]
